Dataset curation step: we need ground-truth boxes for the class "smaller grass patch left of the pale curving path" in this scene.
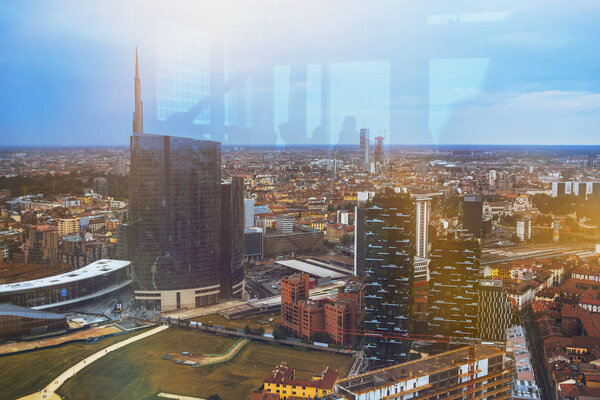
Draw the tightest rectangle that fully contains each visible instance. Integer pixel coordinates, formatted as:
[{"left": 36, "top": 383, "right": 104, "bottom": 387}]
[{"left": 0, "top": 334, "right": 139, "bottom": 399}]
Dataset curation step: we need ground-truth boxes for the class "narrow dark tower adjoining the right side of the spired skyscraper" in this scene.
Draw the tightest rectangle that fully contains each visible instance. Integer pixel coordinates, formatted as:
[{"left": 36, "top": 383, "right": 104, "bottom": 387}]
[{"left": 220, "top": 176, "right": 245, "bottom": 299}]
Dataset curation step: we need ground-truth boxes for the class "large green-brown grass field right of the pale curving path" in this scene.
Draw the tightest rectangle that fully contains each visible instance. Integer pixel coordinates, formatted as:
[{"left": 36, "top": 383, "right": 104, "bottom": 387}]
[{"left": 58, "top": 328, "right": 352, "bottom": 400}]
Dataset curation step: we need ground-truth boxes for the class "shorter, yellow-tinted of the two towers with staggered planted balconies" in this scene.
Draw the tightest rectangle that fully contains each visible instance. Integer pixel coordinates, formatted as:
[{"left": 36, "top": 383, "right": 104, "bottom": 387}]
[{"left": 428, "top": 237, "right": 481, "bottom": 338}]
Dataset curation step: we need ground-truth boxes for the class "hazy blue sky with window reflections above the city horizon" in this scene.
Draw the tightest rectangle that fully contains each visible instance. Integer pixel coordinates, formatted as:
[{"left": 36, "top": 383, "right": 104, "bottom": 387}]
[{"left": 0, "top": 0, "right": 600, "bottom": 146}]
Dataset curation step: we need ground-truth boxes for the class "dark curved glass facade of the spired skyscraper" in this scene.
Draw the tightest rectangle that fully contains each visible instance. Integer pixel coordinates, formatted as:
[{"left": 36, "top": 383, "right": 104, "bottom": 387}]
[{"left": 128, "top": 134, "right": 221, "bottom": 291}]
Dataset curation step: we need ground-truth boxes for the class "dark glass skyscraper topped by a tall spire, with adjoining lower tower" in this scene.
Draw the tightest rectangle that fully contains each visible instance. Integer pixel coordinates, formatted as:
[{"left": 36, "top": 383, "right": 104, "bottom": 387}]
[{"left": 127, "top": 50, "right": 244, "bottom": 311}]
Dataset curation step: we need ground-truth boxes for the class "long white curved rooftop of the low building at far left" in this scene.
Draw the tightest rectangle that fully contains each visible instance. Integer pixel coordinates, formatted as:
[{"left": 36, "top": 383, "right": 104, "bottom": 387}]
[{"left": 0, "top": 259, "right": 130, "bottom": 293}]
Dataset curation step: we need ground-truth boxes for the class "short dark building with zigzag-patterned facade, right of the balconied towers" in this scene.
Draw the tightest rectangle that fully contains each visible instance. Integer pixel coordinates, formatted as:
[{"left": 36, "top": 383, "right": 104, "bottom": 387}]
[{"left": 478, "top": 279, "right": 513, "bottom": 342}]
